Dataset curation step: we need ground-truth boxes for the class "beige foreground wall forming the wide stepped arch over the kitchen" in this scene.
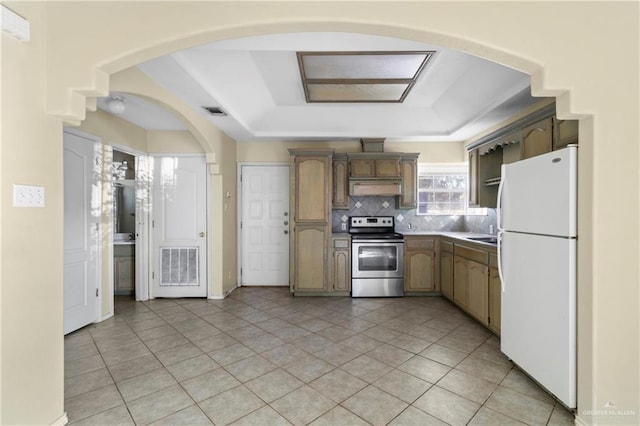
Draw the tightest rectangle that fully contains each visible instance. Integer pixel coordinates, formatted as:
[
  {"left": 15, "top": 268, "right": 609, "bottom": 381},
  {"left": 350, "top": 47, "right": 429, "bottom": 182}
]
[{"left": 0, "top": 1, "right": 640, "bottom": 424}]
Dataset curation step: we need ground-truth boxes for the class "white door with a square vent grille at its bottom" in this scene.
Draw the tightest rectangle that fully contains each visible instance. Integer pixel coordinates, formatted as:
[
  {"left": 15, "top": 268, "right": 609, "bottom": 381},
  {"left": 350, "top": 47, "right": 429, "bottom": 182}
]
[{"left": 151, "top": 156, "right": 207, "bottom": 297}]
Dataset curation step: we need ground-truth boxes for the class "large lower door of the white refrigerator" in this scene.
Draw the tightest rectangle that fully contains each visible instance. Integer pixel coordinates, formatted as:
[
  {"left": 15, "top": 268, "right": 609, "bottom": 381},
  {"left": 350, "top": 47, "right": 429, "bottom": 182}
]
[{"left": 500, "top": 232, "right": 576, "bottom": 408}]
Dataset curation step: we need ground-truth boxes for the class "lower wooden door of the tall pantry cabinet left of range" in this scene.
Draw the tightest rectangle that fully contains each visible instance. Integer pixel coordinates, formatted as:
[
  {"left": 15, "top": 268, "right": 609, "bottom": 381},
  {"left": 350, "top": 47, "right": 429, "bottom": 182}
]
[{"left": 293, "top": 225, "right": 328, "bottom": 292}]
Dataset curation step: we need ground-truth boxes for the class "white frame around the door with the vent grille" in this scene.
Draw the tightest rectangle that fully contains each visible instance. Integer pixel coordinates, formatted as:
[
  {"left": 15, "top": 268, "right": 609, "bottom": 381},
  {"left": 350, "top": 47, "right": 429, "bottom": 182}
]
[{"left": 149, "top": 152, "right": 212, "bottom": 300}]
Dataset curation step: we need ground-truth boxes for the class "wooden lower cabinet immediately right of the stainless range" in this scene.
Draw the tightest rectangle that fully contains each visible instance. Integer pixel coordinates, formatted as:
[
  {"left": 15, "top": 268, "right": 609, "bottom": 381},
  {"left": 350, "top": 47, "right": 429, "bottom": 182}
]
[{"left": 404, "top": 236, "right": 439, "bottom": 293}]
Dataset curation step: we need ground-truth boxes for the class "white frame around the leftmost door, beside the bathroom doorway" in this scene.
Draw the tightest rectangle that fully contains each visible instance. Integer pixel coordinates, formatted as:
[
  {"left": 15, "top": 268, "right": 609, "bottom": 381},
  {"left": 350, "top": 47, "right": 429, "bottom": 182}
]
[{"left": 62, "top": 126, "right": 103, "bottom": 323}]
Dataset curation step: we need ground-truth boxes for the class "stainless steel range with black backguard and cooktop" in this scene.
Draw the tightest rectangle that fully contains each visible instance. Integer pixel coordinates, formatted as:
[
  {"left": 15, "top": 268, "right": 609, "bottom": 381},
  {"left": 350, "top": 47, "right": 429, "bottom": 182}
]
[{"left": 349, "top": 216, "right": 404, "bottom": 297}]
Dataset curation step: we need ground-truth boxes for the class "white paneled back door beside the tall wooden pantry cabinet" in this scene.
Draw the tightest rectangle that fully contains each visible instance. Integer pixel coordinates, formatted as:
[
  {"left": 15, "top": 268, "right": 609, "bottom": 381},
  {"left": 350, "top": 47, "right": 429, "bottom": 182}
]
[{"left": 240, "top": 165, "right": 290, "bottom": 286}]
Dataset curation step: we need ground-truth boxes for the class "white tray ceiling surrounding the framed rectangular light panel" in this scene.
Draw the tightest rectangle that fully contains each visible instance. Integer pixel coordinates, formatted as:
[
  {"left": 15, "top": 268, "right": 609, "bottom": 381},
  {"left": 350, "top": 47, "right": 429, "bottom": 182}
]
[{"left": 97, "top": 32, "right": 539, "bottom": 142}]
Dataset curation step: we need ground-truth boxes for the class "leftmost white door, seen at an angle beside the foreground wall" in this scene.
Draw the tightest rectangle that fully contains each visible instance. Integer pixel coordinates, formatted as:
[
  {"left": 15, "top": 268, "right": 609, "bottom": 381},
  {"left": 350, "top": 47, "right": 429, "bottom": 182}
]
[{"left": 64, "top": 132, "right": 101, "bottom": 334}]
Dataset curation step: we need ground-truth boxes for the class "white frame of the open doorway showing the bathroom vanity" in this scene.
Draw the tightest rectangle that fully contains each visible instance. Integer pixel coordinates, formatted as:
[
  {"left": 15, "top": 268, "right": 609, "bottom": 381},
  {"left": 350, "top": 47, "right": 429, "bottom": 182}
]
[{"left": 105, "top": 142, "right": 151, "bottom": 304}]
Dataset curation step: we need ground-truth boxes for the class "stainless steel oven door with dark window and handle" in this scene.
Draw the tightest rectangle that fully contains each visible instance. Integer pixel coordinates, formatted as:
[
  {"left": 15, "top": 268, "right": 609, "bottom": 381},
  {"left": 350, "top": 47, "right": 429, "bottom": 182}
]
[{"left": 351, "top": 240, "right": 404, "bottom": 278}]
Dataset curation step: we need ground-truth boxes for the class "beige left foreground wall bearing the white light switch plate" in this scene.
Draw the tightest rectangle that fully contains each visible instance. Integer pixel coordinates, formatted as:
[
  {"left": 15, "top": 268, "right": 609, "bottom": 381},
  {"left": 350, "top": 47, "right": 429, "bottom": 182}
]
[{"left": 0, "top": 3, "right": 64, "bottom": 425}]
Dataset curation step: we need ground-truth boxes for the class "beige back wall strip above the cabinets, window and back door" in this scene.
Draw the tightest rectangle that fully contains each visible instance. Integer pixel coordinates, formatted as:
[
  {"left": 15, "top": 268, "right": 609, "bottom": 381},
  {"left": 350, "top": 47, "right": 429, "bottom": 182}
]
[{"left": 237, "top": 141, "right": 467, "bottom": 163}]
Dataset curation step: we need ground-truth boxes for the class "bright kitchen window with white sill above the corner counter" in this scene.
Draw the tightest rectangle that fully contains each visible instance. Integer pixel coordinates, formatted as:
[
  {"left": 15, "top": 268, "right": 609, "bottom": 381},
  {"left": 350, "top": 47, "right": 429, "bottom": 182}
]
[{"left": 417, "top": 163, "right": 487, "bottom": 215}]
